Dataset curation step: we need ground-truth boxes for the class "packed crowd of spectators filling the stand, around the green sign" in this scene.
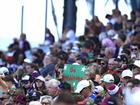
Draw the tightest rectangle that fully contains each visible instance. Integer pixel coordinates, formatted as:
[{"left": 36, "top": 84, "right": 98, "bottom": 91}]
[{"left": 0, "top": 9, "right": 140, "bottom": 105}]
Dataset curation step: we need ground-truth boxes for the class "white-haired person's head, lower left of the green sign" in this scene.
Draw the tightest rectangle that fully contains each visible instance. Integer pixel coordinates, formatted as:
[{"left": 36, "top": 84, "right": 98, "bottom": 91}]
[{"left": 46, "top": 79, "right": 60, "bottom": 97}]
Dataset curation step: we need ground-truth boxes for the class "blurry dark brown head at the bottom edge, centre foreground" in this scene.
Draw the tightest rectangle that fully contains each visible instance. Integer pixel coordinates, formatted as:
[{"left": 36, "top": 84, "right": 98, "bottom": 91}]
[{"left": 53, "top": 92, "right": 76, "bottom": 105}]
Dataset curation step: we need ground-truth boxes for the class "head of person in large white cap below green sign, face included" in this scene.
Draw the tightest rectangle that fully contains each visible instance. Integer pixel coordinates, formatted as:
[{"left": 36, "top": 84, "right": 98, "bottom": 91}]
[{"left": 75, "top": 80, "right": 94, "bottom": 98}]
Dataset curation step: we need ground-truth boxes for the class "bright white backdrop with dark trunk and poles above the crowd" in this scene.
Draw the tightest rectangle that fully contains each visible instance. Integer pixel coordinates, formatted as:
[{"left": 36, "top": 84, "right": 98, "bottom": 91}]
[{"left": 0, "top": 0, "right": 140, "bottom": 50}]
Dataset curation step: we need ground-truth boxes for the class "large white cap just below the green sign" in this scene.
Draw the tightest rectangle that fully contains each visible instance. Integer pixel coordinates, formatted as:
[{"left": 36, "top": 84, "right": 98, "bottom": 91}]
[{"left": 75, "top": 80, "right": 90, "bottom": 93}]
